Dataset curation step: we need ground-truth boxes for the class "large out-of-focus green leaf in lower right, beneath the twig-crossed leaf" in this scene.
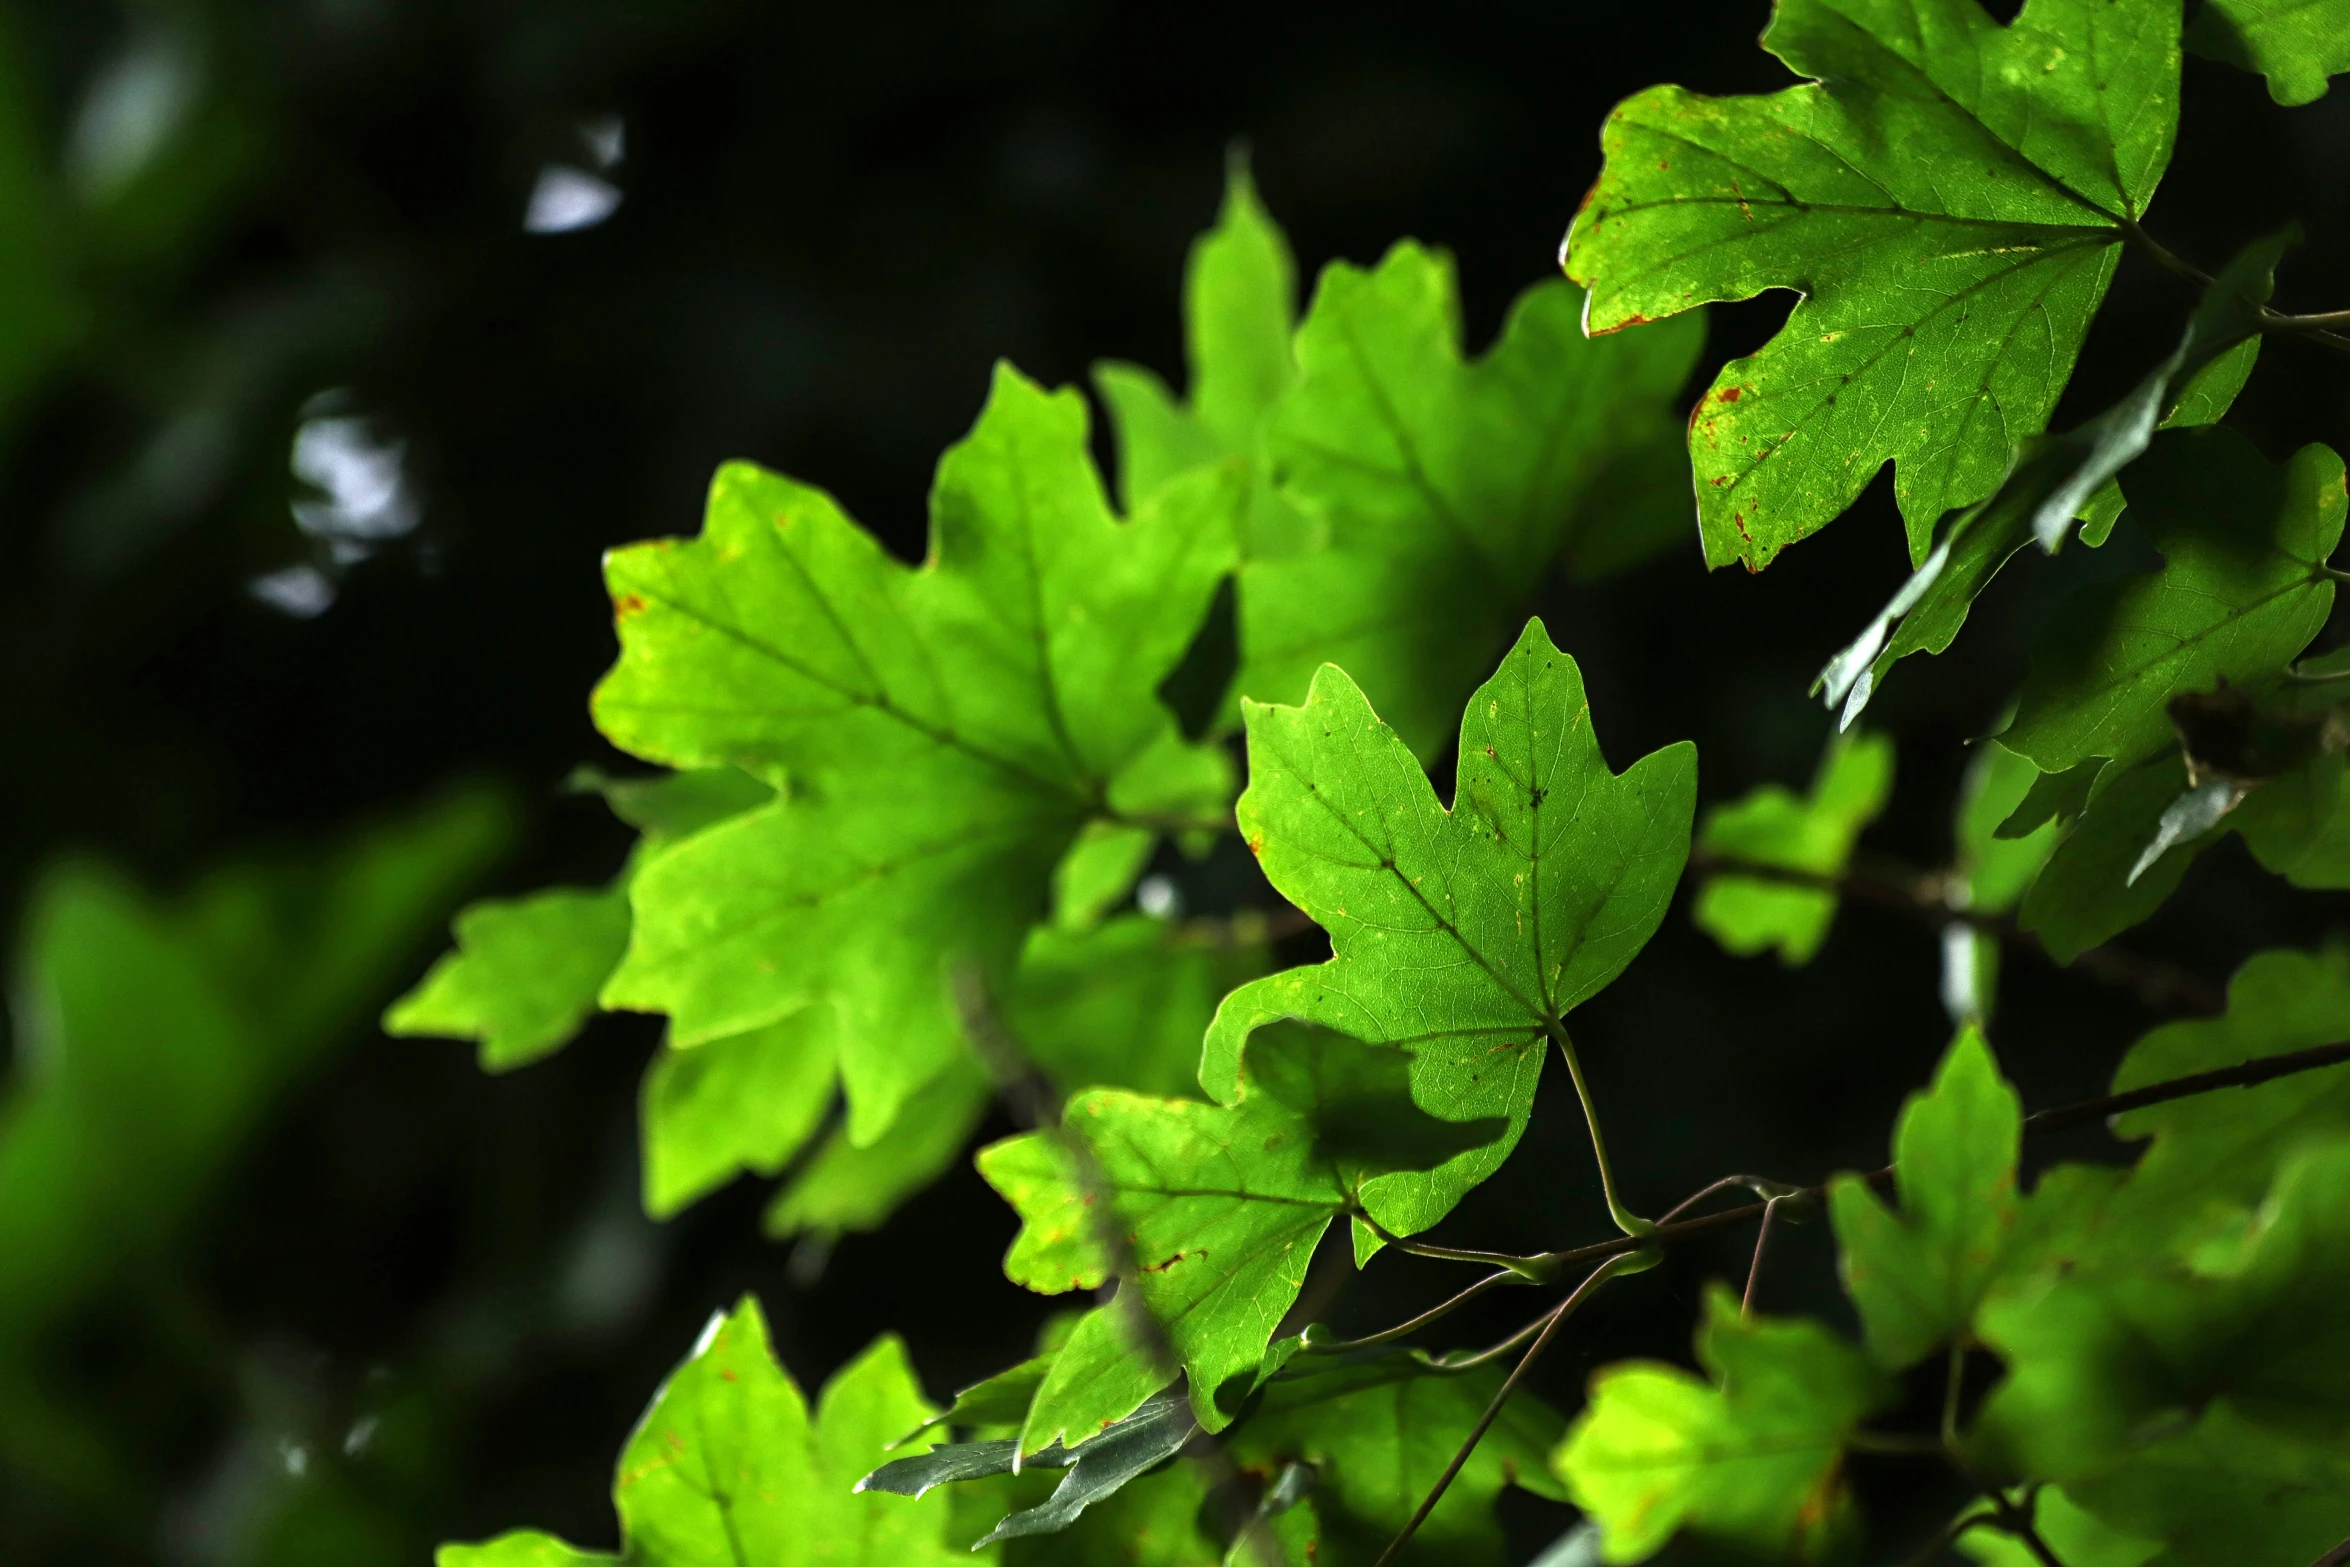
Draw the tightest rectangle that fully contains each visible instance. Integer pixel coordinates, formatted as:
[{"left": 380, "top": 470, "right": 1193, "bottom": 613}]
[{"left": 1979, "top": 1142, "right": 2350, "bottom": 1484}]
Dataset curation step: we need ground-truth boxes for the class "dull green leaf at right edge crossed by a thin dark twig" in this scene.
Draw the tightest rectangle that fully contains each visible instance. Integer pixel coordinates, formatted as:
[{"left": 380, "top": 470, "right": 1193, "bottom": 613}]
[{"left": 2113, "top": 944, "right": 2350, "bottom": 1210}]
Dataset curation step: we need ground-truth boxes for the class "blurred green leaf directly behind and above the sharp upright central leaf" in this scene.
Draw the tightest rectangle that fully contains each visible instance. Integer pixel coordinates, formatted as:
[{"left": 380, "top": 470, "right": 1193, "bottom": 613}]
[{"left": 1241, "top": 256, "right": 1704, "bottom": 759}]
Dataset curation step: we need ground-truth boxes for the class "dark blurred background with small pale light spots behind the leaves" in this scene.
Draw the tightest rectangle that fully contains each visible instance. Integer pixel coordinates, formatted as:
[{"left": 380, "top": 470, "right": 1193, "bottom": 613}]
[{"left": 0, "top": 0, "right": 2350, "bottom": 1565}]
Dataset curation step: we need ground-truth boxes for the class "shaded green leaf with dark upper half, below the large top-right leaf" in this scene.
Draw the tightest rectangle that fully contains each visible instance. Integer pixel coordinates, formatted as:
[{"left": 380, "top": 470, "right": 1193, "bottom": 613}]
[{"left": 2000, "top": 428, "right": 2345, "bottom": 773}]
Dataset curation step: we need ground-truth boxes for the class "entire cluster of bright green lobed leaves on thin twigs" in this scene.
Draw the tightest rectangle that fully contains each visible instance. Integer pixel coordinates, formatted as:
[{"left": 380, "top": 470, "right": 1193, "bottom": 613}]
[{"left": 422, "top": 0, "right": 2350, "bottom": 1567}]
